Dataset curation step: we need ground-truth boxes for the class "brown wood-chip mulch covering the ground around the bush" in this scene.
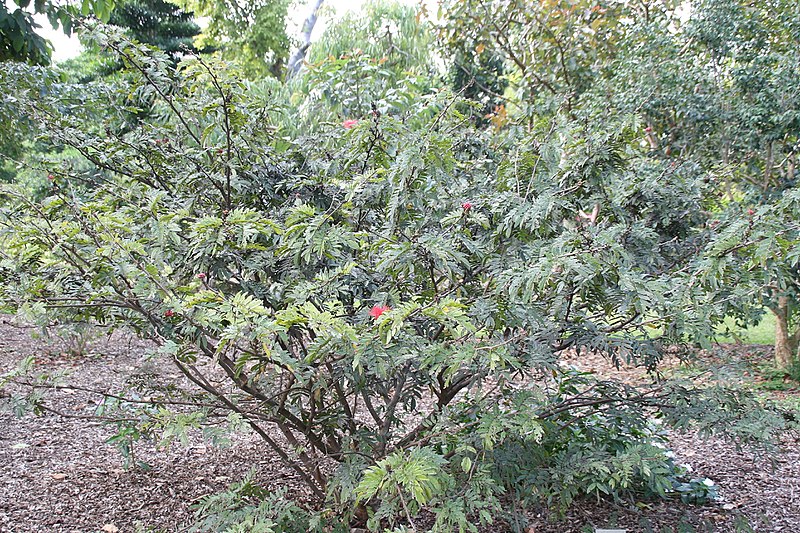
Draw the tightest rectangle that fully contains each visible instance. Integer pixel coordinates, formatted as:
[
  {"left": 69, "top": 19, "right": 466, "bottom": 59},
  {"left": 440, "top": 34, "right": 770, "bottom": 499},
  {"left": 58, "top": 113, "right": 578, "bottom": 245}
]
[{"left": 0, "top": 319, "right": 800, "bottom": 533}]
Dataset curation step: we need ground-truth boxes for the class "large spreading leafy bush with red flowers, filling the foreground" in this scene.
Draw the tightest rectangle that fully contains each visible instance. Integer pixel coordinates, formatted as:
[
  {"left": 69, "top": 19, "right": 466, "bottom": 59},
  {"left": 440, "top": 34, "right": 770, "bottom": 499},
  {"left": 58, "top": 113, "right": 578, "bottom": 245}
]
[{"left": 0, "top": 22, "right": 784, "bottom": 531}]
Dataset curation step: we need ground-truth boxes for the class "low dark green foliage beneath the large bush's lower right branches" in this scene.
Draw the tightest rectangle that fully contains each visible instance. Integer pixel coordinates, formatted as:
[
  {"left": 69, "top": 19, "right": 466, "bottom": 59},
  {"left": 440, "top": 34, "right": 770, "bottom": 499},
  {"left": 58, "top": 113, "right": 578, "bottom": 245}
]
[{"left": 468, "top": 372, "right": 736, "bottom": 509}]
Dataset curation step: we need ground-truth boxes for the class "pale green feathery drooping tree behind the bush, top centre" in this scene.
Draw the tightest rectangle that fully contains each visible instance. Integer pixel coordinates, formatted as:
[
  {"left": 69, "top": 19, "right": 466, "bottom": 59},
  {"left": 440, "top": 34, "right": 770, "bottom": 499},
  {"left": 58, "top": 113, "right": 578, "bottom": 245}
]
[{"left": 286, "top": 2, "right": 444, "bottom": 132}]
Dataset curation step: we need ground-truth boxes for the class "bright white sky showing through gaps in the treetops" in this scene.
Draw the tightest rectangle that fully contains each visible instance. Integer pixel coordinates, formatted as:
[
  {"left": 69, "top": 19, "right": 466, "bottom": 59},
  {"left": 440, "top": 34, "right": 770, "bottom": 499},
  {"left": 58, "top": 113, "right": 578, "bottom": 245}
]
[{"left": 34, "top": 0, "right": 419, "bottom": 63}]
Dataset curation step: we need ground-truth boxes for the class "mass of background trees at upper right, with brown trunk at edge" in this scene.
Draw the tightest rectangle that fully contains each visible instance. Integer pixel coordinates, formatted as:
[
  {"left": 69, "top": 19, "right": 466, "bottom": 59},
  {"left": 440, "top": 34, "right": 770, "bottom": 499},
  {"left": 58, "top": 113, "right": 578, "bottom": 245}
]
[{"left": 440, "top": 0, "right": 800, "bottom": 367}]
